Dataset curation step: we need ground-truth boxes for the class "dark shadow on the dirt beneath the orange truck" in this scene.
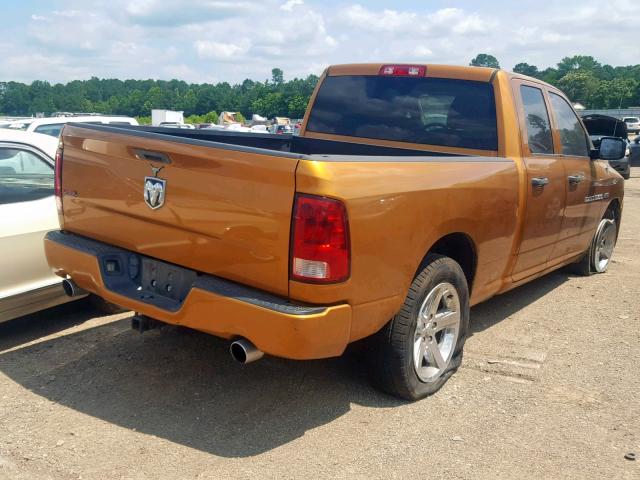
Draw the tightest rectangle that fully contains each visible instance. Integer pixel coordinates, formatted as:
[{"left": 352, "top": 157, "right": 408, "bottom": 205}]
[{"left": 0, "top": 273, "right": 567, "bottom": 457}]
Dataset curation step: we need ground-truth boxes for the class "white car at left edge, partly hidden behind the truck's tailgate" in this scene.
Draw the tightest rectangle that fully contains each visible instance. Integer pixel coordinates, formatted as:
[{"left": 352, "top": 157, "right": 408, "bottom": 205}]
[{"left": 0, "top": 129, "right": 84, "bottom": 322}]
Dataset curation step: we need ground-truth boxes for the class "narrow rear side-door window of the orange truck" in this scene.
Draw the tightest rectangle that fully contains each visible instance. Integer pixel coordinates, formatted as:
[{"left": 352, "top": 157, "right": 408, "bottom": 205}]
[{"left": 520, "top": 85, "right": 553, "bottom": 153}]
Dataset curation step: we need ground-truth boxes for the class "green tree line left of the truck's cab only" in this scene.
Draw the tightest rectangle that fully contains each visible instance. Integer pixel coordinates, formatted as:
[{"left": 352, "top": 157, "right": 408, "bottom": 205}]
[{"left": 0, "top": 68, "right": 318, "bottom": 121}]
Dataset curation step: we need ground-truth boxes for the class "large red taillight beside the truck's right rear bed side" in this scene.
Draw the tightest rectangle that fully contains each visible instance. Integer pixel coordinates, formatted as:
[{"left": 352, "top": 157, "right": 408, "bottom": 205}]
[{"left": 291, "top": 194, "right": 350, "bottom": 283}]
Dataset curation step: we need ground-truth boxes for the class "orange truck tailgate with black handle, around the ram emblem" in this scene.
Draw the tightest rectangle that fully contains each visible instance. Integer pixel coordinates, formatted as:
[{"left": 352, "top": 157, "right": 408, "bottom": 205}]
[{"left": 62, "top": 126, "right": 298, "bottom": 295}]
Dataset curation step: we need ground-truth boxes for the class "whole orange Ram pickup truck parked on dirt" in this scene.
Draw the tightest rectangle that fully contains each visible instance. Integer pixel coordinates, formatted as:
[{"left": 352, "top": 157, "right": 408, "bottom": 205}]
[{"left": 45, "top": 64, "right": 625, "bottom": 399}]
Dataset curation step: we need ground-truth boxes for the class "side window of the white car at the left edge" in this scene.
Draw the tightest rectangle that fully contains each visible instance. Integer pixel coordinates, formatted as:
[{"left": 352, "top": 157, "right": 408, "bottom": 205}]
[{"left": 0, "top": 146, "right": 53, "bottom": 204}]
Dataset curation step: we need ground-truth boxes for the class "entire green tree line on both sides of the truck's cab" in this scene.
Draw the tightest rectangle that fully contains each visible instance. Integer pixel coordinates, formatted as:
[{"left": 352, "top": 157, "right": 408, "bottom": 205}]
[{"left": 0, "top": 57, "right": 640, "bottom": 122}]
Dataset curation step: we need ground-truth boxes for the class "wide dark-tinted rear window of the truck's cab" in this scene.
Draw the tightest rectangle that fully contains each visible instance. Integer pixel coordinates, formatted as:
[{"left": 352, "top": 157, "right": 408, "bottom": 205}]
[{"left": 307, "top": 76, "right": 498, "bottom": 150}]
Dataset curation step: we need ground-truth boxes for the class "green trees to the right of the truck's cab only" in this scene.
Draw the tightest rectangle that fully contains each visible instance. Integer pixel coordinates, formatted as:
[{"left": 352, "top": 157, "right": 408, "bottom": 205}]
[{"left": 471, "top": 53, "right": 640, "bottom": 109}]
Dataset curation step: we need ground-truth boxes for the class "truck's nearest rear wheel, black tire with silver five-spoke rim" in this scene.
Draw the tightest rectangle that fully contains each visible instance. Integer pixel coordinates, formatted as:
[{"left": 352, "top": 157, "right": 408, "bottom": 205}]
[{"left": 369, "top": 254, "right": 469, "bottom": 400}]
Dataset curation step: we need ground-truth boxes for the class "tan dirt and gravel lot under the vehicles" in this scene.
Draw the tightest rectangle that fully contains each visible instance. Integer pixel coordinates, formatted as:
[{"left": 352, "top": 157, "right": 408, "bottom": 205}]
[{"left": 0, "top": 169, "right": 640, "bottom": 479}]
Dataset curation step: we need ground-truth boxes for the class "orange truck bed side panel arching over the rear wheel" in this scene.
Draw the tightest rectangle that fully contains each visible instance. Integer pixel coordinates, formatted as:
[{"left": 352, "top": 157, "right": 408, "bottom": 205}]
[{"left": 289, "top": 157, "right": 518, "bottom": 340}]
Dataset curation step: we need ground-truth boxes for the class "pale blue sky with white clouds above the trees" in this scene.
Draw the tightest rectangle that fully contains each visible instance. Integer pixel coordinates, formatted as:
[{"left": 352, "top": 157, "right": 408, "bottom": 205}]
[{"left": 0, "top": 0, "right": 640, "bottom": 82}]
